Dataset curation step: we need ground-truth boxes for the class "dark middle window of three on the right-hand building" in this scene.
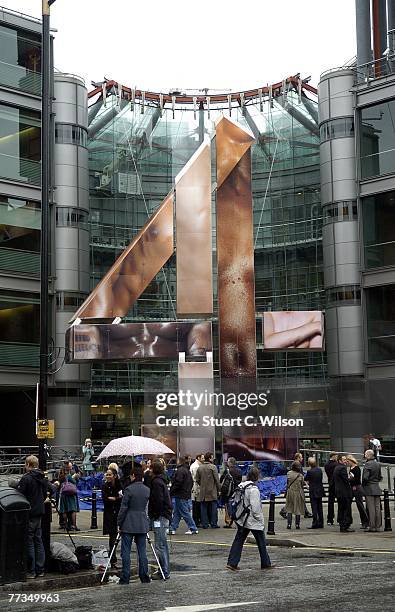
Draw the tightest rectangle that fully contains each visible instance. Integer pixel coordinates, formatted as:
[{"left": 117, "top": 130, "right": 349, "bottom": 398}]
[{"left": 362, "top": 191, "right": 395, "bottom": 268}]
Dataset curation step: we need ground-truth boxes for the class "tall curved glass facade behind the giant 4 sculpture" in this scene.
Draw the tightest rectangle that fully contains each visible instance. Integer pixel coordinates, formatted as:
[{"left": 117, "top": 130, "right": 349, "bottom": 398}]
[{"left": 88, "top": 90, "right": 327, "bottom": 438}]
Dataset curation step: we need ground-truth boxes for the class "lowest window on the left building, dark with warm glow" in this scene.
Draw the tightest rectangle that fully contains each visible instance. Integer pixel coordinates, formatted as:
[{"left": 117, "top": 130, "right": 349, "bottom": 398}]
[{"left": 0, "top": 291, "right": 40, "bottom": 344}]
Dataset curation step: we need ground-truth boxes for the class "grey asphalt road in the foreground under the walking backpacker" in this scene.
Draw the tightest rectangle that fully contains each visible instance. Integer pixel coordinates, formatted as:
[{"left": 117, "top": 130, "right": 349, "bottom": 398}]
[{"left": 0, "top": 530, "right": 395, "bottom": 612}]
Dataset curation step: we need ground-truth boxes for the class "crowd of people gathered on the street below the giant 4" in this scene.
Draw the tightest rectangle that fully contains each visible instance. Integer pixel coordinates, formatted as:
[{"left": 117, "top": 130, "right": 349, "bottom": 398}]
[{"left": 13, "top": 446, "right": 382, "bottom": 584}]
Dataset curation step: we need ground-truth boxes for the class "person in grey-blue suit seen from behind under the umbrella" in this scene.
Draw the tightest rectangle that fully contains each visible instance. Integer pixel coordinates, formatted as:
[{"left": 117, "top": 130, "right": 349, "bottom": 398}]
[{"left": 118, "top": 467, "right": 151, "bottom": 584}]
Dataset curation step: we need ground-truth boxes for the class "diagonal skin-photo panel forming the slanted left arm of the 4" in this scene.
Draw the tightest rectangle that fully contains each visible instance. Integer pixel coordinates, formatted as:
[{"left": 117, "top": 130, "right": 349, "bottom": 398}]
[{"left": 70, "top": 192, "right": 174, "bottom": 322}]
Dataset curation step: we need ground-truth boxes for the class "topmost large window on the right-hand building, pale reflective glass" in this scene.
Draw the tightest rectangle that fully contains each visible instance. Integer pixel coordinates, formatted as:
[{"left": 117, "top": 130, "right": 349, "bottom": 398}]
[{"left": 360, "top": 100, "right": 395, "bottom": 178}]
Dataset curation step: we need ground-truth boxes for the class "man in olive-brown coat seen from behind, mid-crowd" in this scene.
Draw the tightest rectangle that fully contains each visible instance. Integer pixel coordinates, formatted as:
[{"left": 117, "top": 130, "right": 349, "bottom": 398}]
[{"left": 196, "top": 453, "right": 221, "bottom": 529}]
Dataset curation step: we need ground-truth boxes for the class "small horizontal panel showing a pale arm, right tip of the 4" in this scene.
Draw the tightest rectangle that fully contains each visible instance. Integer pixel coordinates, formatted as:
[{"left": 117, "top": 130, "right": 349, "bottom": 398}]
[{"left": 263, "top": 310, "right": 325, "bottom": 352}]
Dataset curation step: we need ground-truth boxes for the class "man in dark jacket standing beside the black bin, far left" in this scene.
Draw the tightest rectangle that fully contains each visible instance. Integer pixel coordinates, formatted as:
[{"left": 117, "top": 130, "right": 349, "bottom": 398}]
[{"left": 17, "top": 455, "right": 48, "bottom": 578}]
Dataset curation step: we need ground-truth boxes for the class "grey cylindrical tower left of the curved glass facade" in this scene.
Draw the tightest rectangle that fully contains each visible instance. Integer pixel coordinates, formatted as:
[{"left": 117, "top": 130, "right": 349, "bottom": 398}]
[{"left": 49, "top": 73, "right": 90, "bottom": 447}]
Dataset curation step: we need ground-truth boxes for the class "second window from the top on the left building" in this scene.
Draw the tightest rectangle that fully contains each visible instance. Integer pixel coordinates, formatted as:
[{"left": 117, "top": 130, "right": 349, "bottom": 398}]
[{"left": 0, "top": 104, "right": 41, "bottom": 185}]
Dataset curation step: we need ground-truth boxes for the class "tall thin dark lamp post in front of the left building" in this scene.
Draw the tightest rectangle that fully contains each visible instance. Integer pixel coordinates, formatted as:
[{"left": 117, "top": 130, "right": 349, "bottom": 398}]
[{"left": 37, "top": 0, "right": 55, "bottom": 470}]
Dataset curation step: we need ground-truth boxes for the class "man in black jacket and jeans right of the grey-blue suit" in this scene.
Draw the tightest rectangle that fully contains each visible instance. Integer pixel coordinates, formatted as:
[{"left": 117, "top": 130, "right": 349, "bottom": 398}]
[{"left": 148, "top": 461, "right": 173, "bottom": 580}]
